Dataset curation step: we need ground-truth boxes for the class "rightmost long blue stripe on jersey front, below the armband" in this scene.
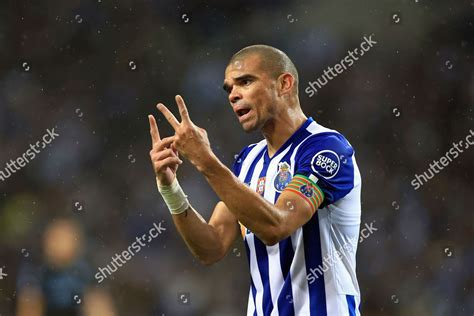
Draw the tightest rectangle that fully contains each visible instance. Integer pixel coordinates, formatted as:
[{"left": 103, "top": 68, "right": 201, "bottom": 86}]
[{"left": 303, "top": 212, "right": 327, "bottom": 316}]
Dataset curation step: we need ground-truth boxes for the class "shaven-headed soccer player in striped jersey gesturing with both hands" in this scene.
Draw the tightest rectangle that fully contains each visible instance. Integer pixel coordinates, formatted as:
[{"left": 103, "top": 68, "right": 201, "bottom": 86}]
[{"left": 149, "top": 45, "right": 361, "bottom": 316}]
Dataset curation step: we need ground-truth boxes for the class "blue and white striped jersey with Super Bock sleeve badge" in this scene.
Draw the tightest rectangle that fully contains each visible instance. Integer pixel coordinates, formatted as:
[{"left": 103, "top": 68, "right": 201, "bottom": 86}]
[{"left": 233, "top": 117, "right": 361, "bottom": 316}]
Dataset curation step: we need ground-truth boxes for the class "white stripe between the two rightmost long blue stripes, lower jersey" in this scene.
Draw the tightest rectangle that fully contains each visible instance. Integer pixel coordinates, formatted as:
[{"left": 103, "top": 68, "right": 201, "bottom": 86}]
[{"left": 290, "top": 227, "right": 310, "bottom": 315}]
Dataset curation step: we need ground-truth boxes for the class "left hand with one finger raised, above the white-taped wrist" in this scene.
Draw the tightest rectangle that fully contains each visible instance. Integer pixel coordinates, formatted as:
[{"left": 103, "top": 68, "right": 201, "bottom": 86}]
[{"left": 148, "top": 115, "right": 183, "bottom": 185}]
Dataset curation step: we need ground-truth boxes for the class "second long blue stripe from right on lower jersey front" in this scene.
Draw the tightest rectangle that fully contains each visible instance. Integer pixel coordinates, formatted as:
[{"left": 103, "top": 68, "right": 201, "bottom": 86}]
[{"left": 278, "top": 236, "right": 295, "bottom": 316}]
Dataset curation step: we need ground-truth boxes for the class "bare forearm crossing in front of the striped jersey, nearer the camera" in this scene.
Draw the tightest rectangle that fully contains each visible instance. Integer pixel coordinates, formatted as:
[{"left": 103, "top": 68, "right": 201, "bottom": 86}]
[{"left": 198, "top": 154, "right": 284, "bottom": 240}]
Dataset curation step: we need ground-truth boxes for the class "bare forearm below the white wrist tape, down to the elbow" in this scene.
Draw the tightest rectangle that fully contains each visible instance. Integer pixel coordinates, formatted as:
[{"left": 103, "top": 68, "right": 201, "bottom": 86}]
[{"left": 172, "top": 206, "right": 223, "bottom": 264}]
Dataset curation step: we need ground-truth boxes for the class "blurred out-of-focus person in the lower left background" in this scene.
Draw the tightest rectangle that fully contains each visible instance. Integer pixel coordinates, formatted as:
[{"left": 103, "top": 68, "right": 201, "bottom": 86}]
[{"left": 16, "top": 219, "right": 116, "bottom": 316}]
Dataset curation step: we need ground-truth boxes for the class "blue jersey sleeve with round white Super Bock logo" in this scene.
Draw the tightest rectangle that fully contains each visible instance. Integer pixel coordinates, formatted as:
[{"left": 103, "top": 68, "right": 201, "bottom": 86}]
[{"left": 294, "top": 133, "right": 354, "bottom": 207}]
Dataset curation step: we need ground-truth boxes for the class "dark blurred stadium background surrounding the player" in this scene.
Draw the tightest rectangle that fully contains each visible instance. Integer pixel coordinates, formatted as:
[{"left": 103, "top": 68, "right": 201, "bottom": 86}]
[{"left": 0, "top": 0, "right": 474, "bottom": 316}]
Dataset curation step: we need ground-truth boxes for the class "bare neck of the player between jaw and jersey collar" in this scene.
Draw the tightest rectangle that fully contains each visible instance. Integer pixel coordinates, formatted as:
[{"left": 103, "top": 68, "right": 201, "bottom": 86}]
[{"left": 262, "top": 110, "right": 308, "bottom": 157}]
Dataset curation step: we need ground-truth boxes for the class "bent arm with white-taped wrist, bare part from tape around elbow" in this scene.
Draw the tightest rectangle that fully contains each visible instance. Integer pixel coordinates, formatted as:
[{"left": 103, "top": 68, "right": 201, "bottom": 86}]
[{"left": 173, "top": 201, "right": 239, "bottom": 265}]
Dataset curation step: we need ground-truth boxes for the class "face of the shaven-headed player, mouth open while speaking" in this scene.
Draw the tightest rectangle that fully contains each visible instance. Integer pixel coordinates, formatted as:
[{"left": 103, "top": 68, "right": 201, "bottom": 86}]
[{"left": 224, "top": 55, "right": 277, "bottom": 132}]
